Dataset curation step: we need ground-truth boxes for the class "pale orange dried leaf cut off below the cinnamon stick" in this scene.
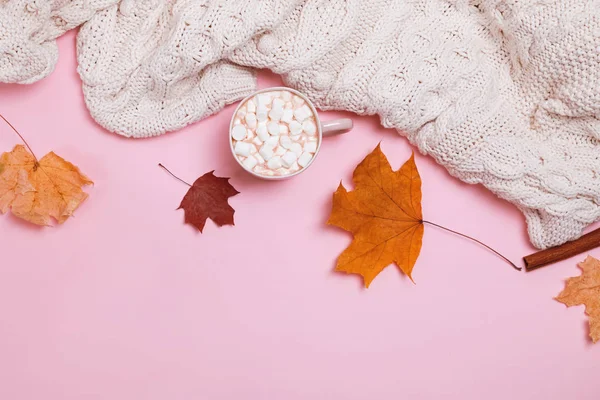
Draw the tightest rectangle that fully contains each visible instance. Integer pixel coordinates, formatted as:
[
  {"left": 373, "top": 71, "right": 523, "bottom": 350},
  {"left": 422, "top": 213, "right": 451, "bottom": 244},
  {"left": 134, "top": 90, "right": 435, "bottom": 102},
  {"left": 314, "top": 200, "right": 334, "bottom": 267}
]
[{"left": 556, "top": 256, "right": 600, "bottom": 343}]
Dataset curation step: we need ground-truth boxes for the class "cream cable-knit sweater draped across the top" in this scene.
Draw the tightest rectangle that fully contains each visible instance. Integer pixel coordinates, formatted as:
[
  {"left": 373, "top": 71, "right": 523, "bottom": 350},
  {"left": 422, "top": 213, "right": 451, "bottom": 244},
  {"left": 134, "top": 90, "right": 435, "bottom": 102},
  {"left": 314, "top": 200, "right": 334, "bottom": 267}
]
[{"left": 0, "top": 0, "right": 600, "bottom": 248}]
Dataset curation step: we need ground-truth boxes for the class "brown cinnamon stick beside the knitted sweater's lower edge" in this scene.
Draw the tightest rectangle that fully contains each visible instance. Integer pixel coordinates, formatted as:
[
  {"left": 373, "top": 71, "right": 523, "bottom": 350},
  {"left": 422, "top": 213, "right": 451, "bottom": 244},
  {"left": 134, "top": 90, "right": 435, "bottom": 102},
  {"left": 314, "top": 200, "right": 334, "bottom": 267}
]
[{"left": 523, "top": 228, "right": 600, "bottom": 271}]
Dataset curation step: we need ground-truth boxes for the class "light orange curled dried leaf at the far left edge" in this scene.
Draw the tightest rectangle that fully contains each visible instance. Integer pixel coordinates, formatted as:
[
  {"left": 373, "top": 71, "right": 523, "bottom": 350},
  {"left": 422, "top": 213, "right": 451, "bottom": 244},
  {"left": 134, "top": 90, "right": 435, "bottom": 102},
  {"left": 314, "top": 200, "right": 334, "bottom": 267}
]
[{"left": 0, "top": 145, "right": 93, "bottom": 226}]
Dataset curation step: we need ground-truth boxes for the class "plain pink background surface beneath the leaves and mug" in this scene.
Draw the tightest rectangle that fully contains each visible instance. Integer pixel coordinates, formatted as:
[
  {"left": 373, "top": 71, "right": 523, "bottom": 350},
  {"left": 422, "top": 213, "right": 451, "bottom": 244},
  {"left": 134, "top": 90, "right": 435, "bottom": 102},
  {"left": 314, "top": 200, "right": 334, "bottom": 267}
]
[{"left": 0, "top": 34, "right": 600, "bottom": 400}]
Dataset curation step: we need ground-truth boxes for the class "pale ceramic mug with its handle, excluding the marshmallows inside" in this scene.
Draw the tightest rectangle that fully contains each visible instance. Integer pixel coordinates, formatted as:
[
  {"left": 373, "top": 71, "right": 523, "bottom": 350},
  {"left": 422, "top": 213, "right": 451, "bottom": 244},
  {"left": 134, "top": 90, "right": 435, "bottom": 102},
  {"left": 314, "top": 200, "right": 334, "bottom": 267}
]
[{"left": 229, "top": 87, "right": 354, "bottom": 180}]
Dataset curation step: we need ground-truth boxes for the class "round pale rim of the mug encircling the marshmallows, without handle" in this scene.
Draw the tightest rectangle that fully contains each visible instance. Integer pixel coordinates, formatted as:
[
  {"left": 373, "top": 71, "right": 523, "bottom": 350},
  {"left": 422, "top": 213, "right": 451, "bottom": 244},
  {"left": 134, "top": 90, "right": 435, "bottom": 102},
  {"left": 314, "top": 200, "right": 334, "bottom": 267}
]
[{"left": 227, "top": 86, "right": 323, "bottom": 181}]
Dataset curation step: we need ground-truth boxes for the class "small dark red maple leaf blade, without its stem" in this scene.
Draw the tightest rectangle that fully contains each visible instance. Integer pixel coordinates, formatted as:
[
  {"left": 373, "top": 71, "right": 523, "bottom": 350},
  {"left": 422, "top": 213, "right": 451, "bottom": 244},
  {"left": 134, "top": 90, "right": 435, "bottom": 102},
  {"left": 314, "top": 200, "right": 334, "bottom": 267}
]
[{"left": 177, "top": 170, "right": 239, "bottom": 232}]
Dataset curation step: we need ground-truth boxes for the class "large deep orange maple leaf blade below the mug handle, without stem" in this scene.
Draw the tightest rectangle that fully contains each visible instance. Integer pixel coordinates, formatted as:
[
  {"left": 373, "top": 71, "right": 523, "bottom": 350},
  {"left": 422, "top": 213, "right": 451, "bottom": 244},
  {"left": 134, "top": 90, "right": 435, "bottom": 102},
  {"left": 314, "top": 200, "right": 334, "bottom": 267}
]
[{"left": 327, "top": 146, "right": 424, "bottom": 287}]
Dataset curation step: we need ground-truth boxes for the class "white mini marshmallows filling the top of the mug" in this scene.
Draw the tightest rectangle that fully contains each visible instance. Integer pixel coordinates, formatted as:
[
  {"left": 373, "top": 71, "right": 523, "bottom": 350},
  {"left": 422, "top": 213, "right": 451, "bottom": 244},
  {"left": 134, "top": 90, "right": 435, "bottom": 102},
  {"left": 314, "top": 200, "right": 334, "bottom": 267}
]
[{"left": 231, "top": 90, "right": 320, "bottom": 177}]
